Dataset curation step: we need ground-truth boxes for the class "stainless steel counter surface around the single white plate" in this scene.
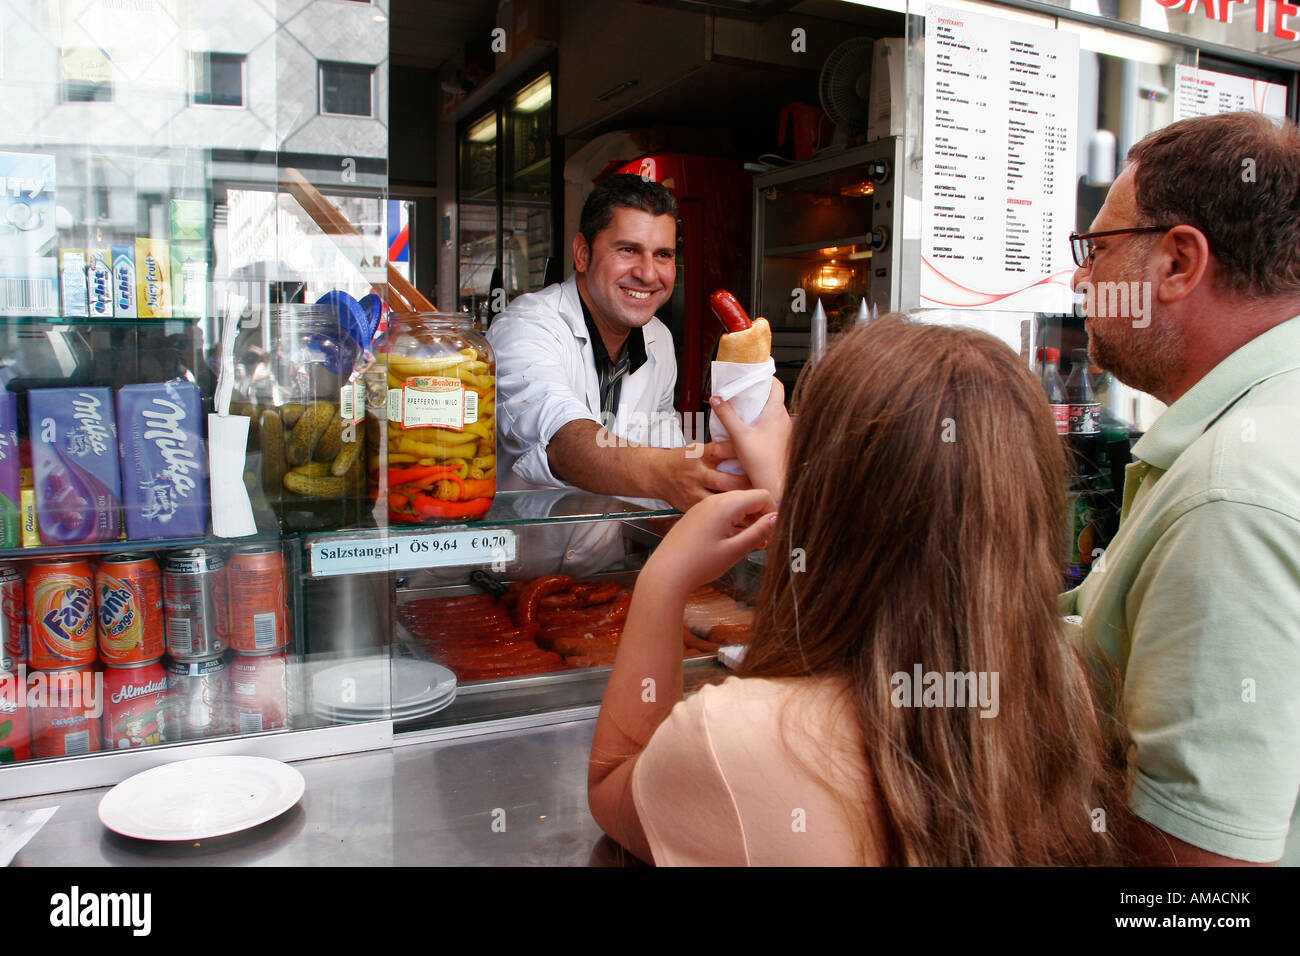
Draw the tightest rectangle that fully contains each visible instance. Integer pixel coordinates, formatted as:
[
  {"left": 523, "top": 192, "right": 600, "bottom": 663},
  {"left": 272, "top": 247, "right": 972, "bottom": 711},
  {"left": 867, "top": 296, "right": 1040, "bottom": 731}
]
[{"left": 0, "top": 719, "right": 636, "bottom": 866}]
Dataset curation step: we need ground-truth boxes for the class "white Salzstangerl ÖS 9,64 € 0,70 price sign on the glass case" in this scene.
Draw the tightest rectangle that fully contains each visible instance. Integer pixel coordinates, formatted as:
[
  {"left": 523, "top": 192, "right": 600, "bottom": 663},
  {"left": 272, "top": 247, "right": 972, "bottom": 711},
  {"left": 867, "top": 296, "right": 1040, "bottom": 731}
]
[{"left": 311, "top": 528, "right": 516, "bottom": 578}]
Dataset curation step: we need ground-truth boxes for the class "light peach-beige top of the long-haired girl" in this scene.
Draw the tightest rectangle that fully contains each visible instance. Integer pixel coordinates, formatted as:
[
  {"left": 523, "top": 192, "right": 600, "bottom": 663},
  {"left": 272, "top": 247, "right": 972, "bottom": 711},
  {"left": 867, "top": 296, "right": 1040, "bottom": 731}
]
[{"left": 632, "top": 678, "right": 881, "bottom": 866}]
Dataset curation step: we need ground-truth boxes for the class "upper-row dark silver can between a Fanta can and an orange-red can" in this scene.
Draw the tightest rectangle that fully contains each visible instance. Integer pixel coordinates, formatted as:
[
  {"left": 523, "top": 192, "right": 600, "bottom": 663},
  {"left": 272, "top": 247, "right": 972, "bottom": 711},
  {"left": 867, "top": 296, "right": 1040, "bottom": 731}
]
[{"left": 163, "top": 548, "right": 229, "bottom": 661}]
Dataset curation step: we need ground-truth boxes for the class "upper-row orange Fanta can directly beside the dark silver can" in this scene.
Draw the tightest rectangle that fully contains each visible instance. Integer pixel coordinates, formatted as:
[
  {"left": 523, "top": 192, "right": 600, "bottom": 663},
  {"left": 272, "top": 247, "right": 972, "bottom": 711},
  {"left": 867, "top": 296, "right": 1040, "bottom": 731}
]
[{"left": 95, "top": 554, "right": 163, "bottom": 665}]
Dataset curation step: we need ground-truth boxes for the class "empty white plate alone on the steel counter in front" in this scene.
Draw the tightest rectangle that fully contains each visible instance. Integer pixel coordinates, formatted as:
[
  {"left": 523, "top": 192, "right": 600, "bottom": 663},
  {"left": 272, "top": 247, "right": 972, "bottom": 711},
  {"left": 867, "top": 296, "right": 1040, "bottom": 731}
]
[{"left": 99, "top": 757, "right": 307, "bottom": 840}]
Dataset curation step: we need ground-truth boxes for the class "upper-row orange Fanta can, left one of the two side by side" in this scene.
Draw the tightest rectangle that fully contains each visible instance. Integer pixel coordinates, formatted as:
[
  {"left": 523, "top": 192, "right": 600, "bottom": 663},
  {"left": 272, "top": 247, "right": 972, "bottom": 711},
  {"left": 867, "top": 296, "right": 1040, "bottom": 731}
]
[{"left": 27, "top": 558, "right": 96, "bottom": 670}]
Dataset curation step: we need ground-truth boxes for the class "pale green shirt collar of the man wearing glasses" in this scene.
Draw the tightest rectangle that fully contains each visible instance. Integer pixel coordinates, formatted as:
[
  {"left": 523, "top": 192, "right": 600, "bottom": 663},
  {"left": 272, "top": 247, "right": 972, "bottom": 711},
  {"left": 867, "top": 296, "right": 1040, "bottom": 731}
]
[{"left": 1134, "top": 315, "right": 1300, "bottom": 471}]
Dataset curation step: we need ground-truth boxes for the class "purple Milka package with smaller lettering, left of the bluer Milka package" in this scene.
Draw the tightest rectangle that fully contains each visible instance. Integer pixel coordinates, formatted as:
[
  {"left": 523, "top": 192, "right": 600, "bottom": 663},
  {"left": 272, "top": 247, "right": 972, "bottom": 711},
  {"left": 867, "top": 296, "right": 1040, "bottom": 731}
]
[{"left": 27, "top": 389, "right": 122, "bottom": 545}]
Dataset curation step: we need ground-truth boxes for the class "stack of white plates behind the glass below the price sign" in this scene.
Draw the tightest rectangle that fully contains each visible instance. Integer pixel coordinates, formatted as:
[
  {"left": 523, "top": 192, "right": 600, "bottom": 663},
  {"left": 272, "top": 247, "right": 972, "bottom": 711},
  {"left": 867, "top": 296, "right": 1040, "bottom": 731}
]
[{"left": 312, "top": 657, "right": 456, "bottom": 723}]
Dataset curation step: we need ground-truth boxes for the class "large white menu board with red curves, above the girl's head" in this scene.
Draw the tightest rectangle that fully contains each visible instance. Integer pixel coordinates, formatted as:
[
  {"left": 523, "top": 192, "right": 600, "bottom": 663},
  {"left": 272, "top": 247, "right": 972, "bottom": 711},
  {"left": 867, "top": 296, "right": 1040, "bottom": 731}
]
[{"left": 920, "top": 5, "right": 1079, "bottom": 312}]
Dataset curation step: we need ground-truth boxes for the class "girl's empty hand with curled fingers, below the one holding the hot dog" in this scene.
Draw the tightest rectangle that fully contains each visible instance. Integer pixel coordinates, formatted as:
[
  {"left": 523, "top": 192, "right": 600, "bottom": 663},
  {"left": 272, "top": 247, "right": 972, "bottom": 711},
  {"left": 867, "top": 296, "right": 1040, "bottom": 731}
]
[{"left": 637, "top": 488, "right": 776, "bottom": 597}]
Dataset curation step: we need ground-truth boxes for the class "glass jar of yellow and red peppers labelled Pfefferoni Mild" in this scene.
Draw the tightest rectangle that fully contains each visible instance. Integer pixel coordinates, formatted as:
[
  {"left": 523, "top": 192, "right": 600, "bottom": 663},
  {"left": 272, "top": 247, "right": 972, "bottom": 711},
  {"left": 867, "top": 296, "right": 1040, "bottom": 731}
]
[{"left": 369, "top": 312, "right": 497, "bottom": 524}]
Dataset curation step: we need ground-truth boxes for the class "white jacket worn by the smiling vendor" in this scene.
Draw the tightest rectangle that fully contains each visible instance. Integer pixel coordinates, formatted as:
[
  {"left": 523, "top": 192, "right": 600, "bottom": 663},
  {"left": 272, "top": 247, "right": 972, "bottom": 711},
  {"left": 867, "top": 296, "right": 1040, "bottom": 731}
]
[{"left": 488, "top": 276, "right": 685, "bottom": 492}]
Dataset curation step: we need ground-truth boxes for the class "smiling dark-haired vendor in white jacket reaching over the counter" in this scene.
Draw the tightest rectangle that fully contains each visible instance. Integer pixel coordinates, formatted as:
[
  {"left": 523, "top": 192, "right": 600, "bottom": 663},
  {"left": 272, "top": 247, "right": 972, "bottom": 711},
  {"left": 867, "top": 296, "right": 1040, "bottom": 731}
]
[{"left": 488, "top": 176, "right": 749, "bottom": 511}]
